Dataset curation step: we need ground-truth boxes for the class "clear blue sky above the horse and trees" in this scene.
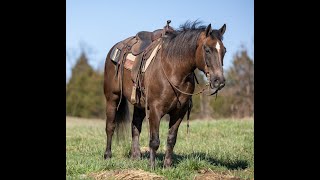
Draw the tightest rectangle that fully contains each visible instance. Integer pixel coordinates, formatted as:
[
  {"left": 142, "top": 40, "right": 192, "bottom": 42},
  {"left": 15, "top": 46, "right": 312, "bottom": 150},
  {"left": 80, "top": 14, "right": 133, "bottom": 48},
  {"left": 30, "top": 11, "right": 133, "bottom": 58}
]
[{"left": 66, "top": 0, "right": 254, "bottom": 79}]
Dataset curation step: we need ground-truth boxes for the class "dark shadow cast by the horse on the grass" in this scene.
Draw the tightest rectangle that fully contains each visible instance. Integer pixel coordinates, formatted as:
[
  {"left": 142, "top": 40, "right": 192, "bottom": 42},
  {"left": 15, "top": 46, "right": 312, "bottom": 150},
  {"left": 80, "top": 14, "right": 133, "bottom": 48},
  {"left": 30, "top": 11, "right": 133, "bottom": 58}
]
[{"left": 141, "top": 152, "right": 249, "bottom": 170}]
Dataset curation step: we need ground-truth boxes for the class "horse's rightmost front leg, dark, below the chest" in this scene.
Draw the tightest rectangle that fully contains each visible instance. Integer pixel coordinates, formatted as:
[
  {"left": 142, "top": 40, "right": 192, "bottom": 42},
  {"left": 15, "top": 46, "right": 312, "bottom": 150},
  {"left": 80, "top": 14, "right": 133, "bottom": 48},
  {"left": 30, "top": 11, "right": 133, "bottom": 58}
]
[{"left": 163, "top": 105, "right": 187, "bottom": 167}]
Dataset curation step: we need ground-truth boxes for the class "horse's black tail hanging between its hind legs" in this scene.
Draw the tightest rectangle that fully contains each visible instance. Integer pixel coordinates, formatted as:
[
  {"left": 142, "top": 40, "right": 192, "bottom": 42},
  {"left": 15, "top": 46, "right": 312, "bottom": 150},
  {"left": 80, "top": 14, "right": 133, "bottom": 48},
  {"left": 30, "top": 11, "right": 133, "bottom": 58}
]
[{"left": 115, "top": 96, "right": 130, "bottom": 141}]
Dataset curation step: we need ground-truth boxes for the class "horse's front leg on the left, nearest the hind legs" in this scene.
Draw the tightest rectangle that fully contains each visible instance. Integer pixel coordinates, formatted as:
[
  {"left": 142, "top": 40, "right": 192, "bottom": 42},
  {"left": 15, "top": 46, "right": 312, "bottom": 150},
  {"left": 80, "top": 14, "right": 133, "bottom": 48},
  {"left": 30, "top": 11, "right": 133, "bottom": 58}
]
[{"left": 149, "top": 107, "right": 163, "bottom": 170}]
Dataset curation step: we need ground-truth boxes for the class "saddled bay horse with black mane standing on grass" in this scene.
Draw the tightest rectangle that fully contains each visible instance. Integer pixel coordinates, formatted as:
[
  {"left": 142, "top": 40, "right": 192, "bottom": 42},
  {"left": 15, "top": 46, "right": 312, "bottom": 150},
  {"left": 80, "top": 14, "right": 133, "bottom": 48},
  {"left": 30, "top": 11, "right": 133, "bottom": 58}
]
[{"left": 104, "top": 21, "right": 226, "bottom": 169}]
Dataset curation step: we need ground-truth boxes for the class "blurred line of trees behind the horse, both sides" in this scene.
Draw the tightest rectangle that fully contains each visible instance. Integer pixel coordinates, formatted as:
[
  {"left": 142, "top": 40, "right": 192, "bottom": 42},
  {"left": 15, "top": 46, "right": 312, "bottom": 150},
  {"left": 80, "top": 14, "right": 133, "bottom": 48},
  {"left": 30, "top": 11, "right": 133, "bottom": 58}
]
[{"left": 66, "top": 49, "right": 254, "bottom": 119}]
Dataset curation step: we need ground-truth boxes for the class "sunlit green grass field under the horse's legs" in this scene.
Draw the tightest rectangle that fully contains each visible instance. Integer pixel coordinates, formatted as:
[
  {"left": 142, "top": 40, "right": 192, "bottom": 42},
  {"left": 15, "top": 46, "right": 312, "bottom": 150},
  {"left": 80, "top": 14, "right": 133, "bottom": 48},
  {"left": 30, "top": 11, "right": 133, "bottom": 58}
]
[{"left": 66, "top": 117, "right": 254, "bottom": 179}]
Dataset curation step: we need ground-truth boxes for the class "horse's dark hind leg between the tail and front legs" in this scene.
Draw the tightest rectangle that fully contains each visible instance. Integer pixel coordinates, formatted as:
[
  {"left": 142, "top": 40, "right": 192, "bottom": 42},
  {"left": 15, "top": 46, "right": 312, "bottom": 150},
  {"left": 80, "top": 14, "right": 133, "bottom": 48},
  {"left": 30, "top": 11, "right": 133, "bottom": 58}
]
[{"left": 131, "top": 107, "right": 146, "bottom": 159}]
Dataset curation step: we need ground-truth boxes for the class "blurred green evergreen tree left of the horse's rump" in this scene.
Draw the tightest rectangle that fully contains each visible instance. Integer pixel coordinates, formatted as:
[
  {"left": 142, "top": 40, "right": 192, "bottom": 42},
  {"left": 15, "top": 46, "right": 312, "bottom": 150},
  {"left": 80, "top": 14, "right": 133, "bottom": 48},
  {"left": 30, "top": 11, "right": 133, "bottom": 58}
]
[{"left": 66, "top": 53, "right": 105, "bottom": 118}]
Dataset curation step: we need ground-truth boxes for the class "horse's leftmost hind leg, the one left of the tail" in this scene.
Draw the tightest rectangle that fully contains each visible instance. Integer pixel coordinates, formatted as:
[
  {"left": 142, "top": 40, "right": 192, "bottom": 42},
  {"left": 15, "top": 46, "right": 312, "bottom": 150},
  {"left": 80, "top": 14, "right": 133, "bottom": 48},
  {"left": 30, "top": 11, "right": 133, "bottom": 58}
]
[{"left": 104, "top": 94, "right": 118, "bottom": 159}]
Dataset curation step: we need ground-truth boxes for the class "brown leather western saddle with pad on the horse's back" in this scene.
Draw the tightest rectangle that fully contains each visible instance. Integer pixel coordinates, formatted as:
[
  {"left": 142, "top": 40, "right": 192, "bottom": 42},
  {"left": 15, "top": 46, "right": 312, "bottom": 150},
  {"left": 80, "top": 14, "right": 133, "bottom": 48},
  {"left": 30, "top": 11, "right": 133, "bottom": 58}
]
[{"left": 111, "top": 20, "right": 174, "bottom": 103}]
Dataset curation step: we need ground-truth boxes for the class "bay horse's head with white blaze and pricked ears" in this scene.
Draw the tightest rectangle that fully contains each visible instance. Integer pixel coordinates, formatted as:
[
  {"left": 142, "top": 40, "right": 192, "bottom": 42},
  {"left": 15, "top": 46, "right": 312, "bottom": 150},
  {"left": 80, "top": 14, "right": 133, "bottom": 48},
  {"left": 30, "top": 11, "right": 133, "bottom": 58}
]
[{"left": 196, "top": 24, "right": 226, "bottom": 95}]
